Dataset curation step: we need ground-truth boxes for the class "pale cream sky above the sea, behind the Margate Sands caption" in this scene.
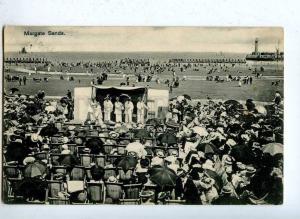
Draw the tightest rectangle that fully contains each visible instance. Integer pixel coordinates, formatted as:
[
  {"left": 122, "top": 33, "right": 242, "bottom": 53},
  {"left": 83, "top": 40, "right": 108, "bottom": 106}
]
[{"left": 4, "top": 26, "right": 284, "bottom": 53}]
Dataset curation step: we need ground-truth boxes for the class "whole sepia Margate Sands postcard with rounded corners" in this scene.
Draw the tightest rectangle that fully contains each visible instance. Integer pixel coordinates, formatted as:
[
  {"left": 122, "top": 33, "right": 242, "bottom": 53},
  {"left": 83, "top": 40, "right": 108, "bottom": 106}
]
[{"left": 1, "top": 26, "right": 284, "bottom": 205}]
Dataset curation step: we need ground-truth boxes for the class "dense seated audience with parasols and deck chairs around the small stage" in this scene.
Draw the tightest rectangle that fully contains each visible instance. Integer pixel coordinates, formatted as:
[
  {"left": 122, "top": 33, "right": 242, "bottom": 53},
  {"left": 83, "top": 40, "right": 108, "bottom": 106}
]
[{"left": 3, "top": 92, "right": 283, "bottom": 205}]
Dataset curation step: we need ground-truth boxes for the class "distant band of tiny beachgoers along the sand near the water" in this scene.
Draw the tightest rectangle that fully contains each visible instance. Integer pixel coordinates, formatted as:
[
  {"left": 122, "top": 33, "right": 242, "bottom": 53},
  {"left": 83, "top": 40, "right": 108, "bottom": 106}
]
[{"left": 6, "top": 58, "right": 256, "bottom": 76}]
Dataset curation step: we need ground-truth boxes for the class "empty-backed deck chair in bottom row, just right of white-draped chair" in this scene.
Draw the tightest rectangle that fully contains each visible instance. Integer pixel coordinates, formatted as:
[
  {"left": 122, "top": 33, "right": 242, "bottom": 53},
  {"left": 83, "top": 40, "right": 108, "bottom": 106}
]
[{"left": 87, "top": 182, "right": 105, "bottom": 204}]
